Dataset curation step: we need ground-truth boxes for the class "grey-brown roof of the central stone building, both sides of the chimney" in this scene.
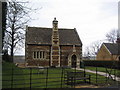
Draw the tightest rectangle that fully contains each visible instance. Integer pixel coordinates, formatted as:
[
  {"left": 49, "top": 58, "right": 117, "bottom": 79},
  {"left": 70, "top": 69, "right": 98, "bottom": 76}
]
[{"left": 26, "top": 27, "right": 82, "bottom": 46}]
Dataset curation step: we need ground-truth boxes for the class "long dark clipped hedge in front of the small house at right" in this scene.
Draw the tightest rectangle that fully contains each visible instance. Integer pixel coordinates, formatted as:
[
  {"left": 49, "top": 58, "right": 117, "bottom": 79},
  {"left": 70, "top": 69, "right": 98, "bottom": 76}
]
[{"left": 81, "top": 60, "right": 120, "bottom": 69}]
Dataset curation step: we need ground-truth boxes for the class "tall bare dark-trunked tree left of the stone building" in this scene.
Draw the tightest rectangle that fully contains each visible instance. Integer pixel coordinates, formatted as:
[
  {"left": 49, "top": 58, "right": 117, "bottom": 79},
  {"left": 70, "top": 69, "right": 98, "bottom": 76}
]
[{"left": 4, "top": 0, "right": 30, "bottom": 62}]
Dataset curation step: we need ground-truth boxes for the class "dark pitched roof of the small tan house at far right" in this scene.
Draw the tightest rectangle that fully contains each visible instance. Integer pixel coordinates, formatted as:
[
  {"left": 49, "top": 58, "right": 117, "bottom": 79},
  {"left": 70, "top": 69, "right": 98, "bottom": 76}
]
[{"left": 103, "top": 43, "right": 120, "bottom": 55}]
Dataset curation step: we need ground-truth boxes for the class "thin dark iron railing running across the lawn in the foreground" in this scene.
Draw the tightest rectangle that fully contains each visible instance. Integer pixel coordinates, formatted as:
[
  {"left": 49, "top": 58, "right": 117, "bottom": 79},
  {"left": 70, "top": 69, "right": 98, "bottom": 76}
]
[{"left": 2, "top": 67, "right": 117, "bottom": 89}]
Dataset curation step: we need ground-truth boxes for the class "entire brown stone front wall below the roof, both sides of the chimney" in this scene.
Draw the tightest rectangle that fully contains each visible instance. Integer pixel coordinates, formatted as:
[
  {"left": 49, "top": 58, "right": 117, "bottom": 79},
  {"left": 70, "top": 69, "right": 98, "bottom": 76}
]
[{"left": 25, "top": 45, "right": 82, "bottom": 66}]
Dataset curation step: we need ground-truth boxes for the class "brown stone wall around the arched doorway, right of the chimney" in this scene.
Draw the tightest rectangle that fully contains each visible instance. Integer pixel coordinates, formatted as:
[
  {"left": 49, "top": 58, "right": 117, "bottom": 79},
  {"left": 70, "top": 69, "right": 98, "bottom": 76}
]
[{"left": 60, "top": 46, "right": 82, "bottom": 66}]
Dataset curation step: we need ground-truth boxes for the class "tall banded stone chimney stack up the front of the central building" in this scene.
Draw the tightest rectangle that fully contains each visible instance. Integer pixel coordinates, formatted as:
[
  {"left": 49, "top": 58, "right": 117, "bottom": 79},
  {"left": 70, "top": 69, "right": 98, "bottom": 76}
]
[{"left": 51, "top": 18, "right": 60, "bottom": 67}]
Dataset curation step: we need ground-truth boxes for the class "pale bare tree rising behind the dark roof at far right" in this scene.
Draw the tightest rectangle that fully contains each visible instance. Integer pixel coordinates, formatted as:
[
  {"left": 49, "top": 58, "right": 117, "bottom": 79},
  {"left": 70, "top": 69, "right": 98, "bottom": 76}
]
[{"left": 106, "top": 29, "right": 118, "bottom": 43}]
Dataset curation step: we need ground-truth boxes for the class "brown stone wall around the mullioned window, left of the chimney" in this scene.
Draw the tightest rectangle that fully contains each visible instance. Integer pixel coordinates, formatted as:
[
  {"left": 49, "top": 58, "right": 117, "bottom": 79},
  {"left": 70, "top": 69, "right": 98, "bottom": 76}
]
[{"left": 25, "top": 45, "right": 51, "bottom": 66}]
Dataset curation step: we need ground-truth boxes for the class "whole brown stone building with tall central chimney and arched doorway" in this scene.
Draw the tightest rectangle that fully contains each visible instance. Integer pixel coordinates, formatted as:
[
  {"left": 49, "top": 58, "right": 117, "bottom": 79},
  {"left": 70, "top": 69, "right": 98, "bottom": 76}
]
[{"left": 25, "top": 18, "right": 82, "bottom": 67}]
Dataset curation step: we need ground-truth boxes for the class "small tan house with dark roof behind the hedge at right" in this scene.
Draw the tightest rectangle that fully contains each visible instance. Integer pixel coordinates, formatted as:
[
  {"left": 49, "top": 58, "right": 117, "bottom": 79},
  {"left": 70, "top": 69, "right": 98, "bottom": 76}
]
[{"left": 96, "top": 43, "right": 120, "bottom": 61}]
